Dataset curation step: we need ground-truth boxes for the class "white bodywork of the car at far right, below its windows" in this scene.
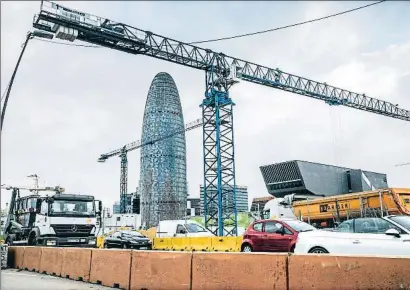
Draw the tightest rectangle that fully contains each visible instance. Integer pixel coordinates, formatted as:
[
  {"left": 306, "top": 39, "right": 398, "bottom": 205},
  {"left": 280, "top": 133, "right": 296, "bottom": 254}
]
[{"left": 294, "top": 216, "right": 410, "bottom": 256}]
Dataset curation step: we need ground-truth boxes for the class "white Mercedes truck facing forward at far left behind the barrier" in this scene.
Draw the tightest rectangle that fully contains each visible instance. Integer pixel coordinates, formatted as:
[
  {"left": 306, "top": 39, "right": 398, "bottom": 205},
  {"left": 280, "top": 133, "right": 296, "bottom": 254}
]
[{"left": 4, "top": 187, "right": 102, "bottom": 247}]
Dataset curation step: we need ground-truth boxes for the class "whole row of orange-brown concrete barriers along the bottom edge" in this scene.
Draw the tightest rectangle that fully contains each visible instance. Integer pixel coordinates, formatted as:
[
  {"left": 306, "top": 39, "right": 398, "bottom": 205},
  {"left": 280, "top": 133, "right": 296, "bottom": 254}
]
[{"left": 9, "top": 247, "right": 410, "bottom": 290}]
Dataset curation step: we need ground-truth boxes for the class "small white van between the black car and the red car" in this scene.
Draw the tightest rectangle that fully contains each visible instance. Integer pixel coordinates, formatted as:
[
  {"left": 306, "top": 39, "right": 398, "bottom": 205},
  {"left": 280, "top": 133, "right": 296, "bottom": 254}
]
[{"left": 156, "top": 220, "right": 214, "bottom": 238}]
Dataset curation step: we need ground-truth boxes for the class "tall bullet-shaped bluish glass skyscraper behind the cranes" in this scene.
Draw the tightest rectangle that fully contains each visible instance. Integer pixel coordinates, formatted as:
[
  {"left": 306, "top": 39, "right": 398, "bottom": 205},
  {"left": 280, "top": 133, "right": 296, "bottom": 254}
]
[{"left": 139, "top": 72, "right": 188, "bottom": 228}]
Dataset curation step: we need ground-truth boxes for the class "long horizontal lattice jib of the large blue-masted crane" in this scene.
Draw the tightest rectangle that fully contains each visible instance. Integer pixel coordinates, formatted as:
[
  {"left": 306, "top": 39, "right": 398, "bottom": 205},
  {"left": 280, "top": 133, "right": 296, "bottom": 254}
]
[{"left": 33, "top": 1, "right": 410, "bottom": 121}]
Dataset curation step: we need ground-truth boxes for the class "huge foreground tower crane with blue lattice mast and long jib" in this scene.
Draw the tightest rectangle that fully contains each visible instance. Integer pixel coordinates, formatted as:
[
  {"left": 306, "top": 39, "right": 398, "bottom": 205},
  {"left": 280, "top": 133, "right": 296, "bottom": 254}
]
[{"left": 33, "top": 1, "right": 410, "bottom": 236}]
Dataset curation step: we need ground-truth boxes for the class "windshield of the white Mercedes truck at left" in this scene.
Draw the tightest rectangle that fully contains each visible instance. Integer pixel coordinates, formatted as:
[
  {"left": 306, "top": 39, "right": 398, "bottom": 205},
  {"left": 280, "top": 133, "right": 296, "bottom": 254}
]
[{"left": 50, "top": 200, "right": 94, "bottom": 216}]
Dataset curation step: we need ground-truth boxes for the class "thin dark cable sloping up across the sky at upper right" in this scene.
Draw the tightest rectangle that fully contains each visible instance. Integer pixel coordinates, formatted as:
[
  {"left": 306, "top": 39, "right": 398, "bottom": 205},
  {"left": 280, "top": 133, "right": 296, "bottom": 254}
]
[{"left": 188, "top": 0, "right": 386, "bottom": 44}]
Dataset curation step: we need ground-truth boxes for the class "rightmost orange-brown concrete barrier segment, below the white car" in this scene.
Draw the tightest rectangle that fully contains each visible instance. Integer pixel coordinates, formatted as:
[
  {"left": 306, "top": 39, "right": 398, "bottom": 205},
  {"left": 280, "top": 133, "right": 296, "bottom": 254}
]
[{"left": 288, "top": 255, "right": 410, "bottom": 290}]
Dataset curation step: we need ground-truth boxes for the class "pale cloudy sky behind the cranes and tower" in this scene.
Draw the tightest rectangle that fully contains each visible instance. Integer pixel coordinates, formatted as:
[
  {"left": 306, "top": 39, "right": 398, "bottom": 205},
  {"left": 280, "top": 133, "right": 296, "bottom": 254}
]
[{"left": 1, "top": 1, "right": 410, "bottom": 208}]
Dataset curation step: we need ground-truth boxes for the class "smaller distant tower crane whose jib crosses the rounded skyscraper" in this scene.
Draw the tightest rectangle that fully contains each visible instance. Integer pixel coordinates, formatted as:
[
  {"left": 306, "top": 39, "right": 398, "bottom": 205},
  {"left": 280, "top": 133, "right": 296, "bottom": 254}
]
[{"left": 98, "top": 119, "right": 202, "bottom": 213}]
